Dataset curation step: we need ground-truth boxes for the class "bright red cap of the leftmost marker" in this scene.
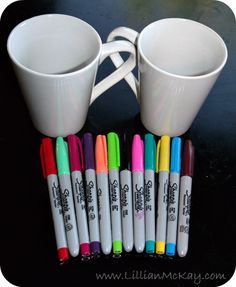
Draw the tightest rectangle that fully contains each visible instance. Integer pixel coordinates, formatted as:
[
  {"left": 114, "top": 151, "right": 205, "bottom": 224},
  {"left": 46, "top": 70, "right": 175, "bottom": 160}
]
[{"left": 40, "top": 138, "right": 57, "bottom": 177}]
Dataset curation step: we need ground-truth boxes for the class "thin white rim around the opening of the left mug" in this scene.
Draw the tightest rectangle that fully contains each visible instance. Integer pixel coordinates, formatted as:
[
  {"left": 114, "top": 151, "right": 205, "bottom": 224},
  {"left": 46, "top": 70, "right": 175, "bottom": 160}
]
[{"left": 7, "top": 13, "right": 102, "bottom": 78}]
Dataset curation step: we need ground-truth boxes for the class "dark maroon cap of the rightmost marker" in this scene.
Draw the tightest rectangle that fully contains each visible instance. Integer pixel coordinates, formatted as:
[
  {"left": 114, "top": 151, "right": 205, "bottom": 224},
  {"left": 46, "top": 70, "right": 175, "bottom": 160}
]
[{"left": 181, "top": 140, "right": 194, "bottom": 177}]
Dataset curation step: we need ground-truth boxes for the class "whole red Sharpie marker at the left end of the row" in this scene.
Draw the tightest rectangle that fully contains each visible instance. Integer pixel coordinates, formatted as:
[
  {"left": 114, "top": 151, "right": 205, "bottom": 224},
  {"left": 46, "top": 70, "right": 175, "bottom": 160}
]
[{"left": 40, "top": 138, "right": 69, "bottom": 263}]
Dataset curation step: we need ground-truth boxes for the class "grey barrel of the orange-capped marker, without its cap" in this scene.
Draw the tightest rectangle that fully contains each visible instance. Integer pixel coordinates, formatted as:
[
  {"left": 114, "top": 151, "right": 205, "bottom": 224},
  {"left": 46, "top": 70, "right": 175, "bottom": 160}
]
[{"left": 97, "top": 173, "right": 112, "bottom": 254}]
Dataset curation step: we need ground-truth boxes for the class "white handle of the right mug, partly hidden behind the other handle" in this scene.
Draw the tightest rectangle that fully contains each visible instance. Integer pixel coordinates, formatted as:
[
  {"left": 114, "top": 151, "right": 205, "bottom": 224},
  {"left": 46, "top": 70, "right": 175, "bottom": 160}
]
[{"left": 107, "top": 27, "right": 140, "bottom": 102}]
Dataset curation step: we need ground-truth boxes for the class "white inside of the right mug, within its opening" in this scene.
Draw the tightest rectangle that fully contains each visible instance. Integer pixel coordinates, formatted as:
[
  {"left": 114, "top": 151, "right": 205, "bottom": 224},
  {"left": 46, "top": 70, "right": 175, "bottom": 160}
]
[{"left": 138, "top": 18, "right": 227, "bottom": 77}]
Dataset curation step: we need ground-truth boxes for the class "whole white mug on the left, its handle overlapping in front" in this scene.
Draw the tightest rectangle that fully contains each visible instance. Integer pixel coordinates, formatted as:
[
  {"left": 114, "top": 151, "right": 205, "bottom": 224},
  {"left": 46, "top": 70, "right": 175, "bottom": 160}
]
[{"left": 7, "top": 14, "right": 135, "bottom": 137}]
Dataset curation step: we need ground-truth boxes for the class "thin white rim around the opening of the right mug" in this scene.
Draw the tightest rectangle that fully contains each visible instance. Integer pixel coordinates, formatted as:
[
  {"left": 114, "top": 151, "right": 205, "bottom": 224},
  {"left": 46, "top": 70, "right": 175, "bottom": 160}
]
[{"left": 137, "top": 18, "right": 228, "bottom": 80}]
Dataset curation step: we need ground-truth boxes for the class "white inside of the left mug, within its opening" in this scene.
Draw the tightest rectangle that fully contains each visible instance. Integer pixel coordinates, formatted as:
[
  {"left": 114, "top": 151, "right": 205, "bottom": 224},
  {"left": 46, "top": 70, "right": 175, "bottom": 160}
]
[{"left": 7, "top": 14, "right": 101, "bottom": 75}]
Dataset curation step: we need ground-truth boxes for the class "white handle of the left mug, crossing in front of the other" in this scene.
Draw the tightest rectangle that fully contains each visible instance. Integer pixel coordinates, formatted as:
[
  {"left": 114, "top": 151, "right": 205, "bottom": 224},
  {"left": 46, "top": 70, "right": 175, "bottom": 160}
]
[{"left": 90, "top": 40, "right": 136, "bottom": 104}]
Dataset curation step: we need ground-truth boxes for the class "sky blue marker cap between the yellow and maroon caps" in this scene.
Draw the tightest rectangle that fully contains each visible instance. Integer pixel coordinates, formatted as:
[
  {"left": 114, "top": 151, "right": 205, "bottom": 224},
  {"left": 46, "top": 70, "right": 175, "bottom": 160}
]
[{"left": 170, "top": 137, "right": 181, "bottom": 173}]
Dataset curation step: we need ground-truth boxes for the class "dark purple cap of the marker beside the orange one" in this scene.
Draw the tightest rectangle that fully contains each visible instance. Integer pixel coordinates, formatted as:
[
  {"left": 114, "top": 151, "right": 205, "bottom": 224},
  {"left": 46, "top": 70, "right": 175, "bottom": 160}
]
[{"left": 82, "top": 133, "right": 95, "bottom": 169}]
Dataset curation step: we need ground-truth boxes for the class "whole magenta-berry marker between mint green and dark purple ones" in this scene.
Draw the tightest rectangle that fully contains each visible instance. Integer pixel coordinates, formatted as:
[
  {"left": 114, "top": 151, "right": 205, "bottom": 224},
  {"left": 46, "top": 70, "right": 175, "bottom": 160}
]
[{"left": 67, "top": 135, "right": 90, "bottom": 258}]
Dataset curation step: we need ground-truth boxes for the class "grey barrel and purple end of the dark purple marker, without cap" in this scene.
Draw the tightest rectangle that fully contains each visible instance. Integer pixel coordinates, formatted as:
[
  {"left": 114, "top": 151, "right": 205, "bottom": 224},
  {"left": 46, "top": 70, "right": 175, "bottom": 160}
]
[{"left": 85, "top": 169, "right": 101, "bottom": 254}]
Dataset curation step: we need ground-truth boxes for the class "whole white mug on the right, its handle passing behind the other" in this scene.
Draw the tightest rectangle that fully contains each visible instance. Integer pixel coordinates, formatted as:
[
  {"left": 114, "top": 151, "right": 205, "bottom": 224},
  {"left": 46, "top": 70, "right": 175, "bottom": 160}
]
[{"left": 107, "top": 18, "right": 228, "bottom": 136}]
